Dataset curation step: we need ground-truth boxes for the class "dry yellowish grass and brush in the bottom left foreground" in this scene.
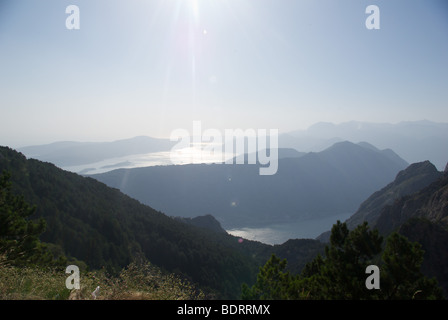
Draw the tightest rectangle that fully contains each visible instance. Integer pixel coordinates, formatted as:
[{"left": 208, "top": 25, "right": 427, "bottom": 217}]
[{"left": 0, "top": 256, "right": 204, "bottom": 300}]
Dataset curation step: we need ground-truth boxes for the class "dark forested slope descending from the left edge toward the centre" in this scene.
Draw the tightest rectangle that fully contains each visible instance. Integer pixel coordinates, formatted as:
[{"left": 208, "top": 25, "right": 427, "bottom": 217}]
[{"left": 0, "top": 148, "right": 256, "bottom": 297}]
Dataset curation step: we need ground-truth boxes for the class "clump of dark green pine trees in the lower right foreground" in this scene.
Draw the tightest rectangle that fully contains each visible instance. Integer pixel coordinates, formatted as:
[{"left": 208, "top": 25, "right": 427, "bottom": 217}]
[{"left": 242, "top": 221, "right": 443, "bottom": 300}]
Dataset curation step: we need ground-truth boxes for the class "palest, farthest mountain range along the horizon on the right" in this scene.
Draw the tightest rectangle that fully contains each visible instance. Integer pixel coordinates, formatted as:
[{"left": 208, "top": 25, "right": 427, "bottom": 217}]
[{"left": 279, "top": 120, "right": 448, "bottom": 170}]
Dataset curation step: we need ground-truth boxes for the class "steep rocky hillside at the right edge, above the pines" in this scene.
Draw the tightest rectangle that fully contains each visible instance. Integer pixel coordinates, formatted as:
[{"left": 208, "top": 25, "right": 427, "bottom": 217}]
[{"left": 318, "top": 161, "right": 448, "bottom": 296}]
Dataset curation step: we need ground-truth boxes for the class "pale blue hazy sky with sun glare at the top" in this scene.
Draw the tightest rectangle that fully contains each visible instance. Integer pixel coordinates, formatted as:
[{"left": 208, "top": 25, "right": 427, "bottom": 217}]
[{"left": 0, "top": 0, "right": 448, "bottom": 148}]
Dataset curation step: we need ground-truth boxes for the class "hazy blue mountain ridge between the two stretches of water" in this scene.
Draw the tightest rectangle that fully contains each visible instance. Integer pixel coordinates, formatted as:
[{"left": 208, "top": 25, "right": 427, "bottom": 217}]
[{"left": 91, "top": 142, "right": 408, "bottom": 228}]
